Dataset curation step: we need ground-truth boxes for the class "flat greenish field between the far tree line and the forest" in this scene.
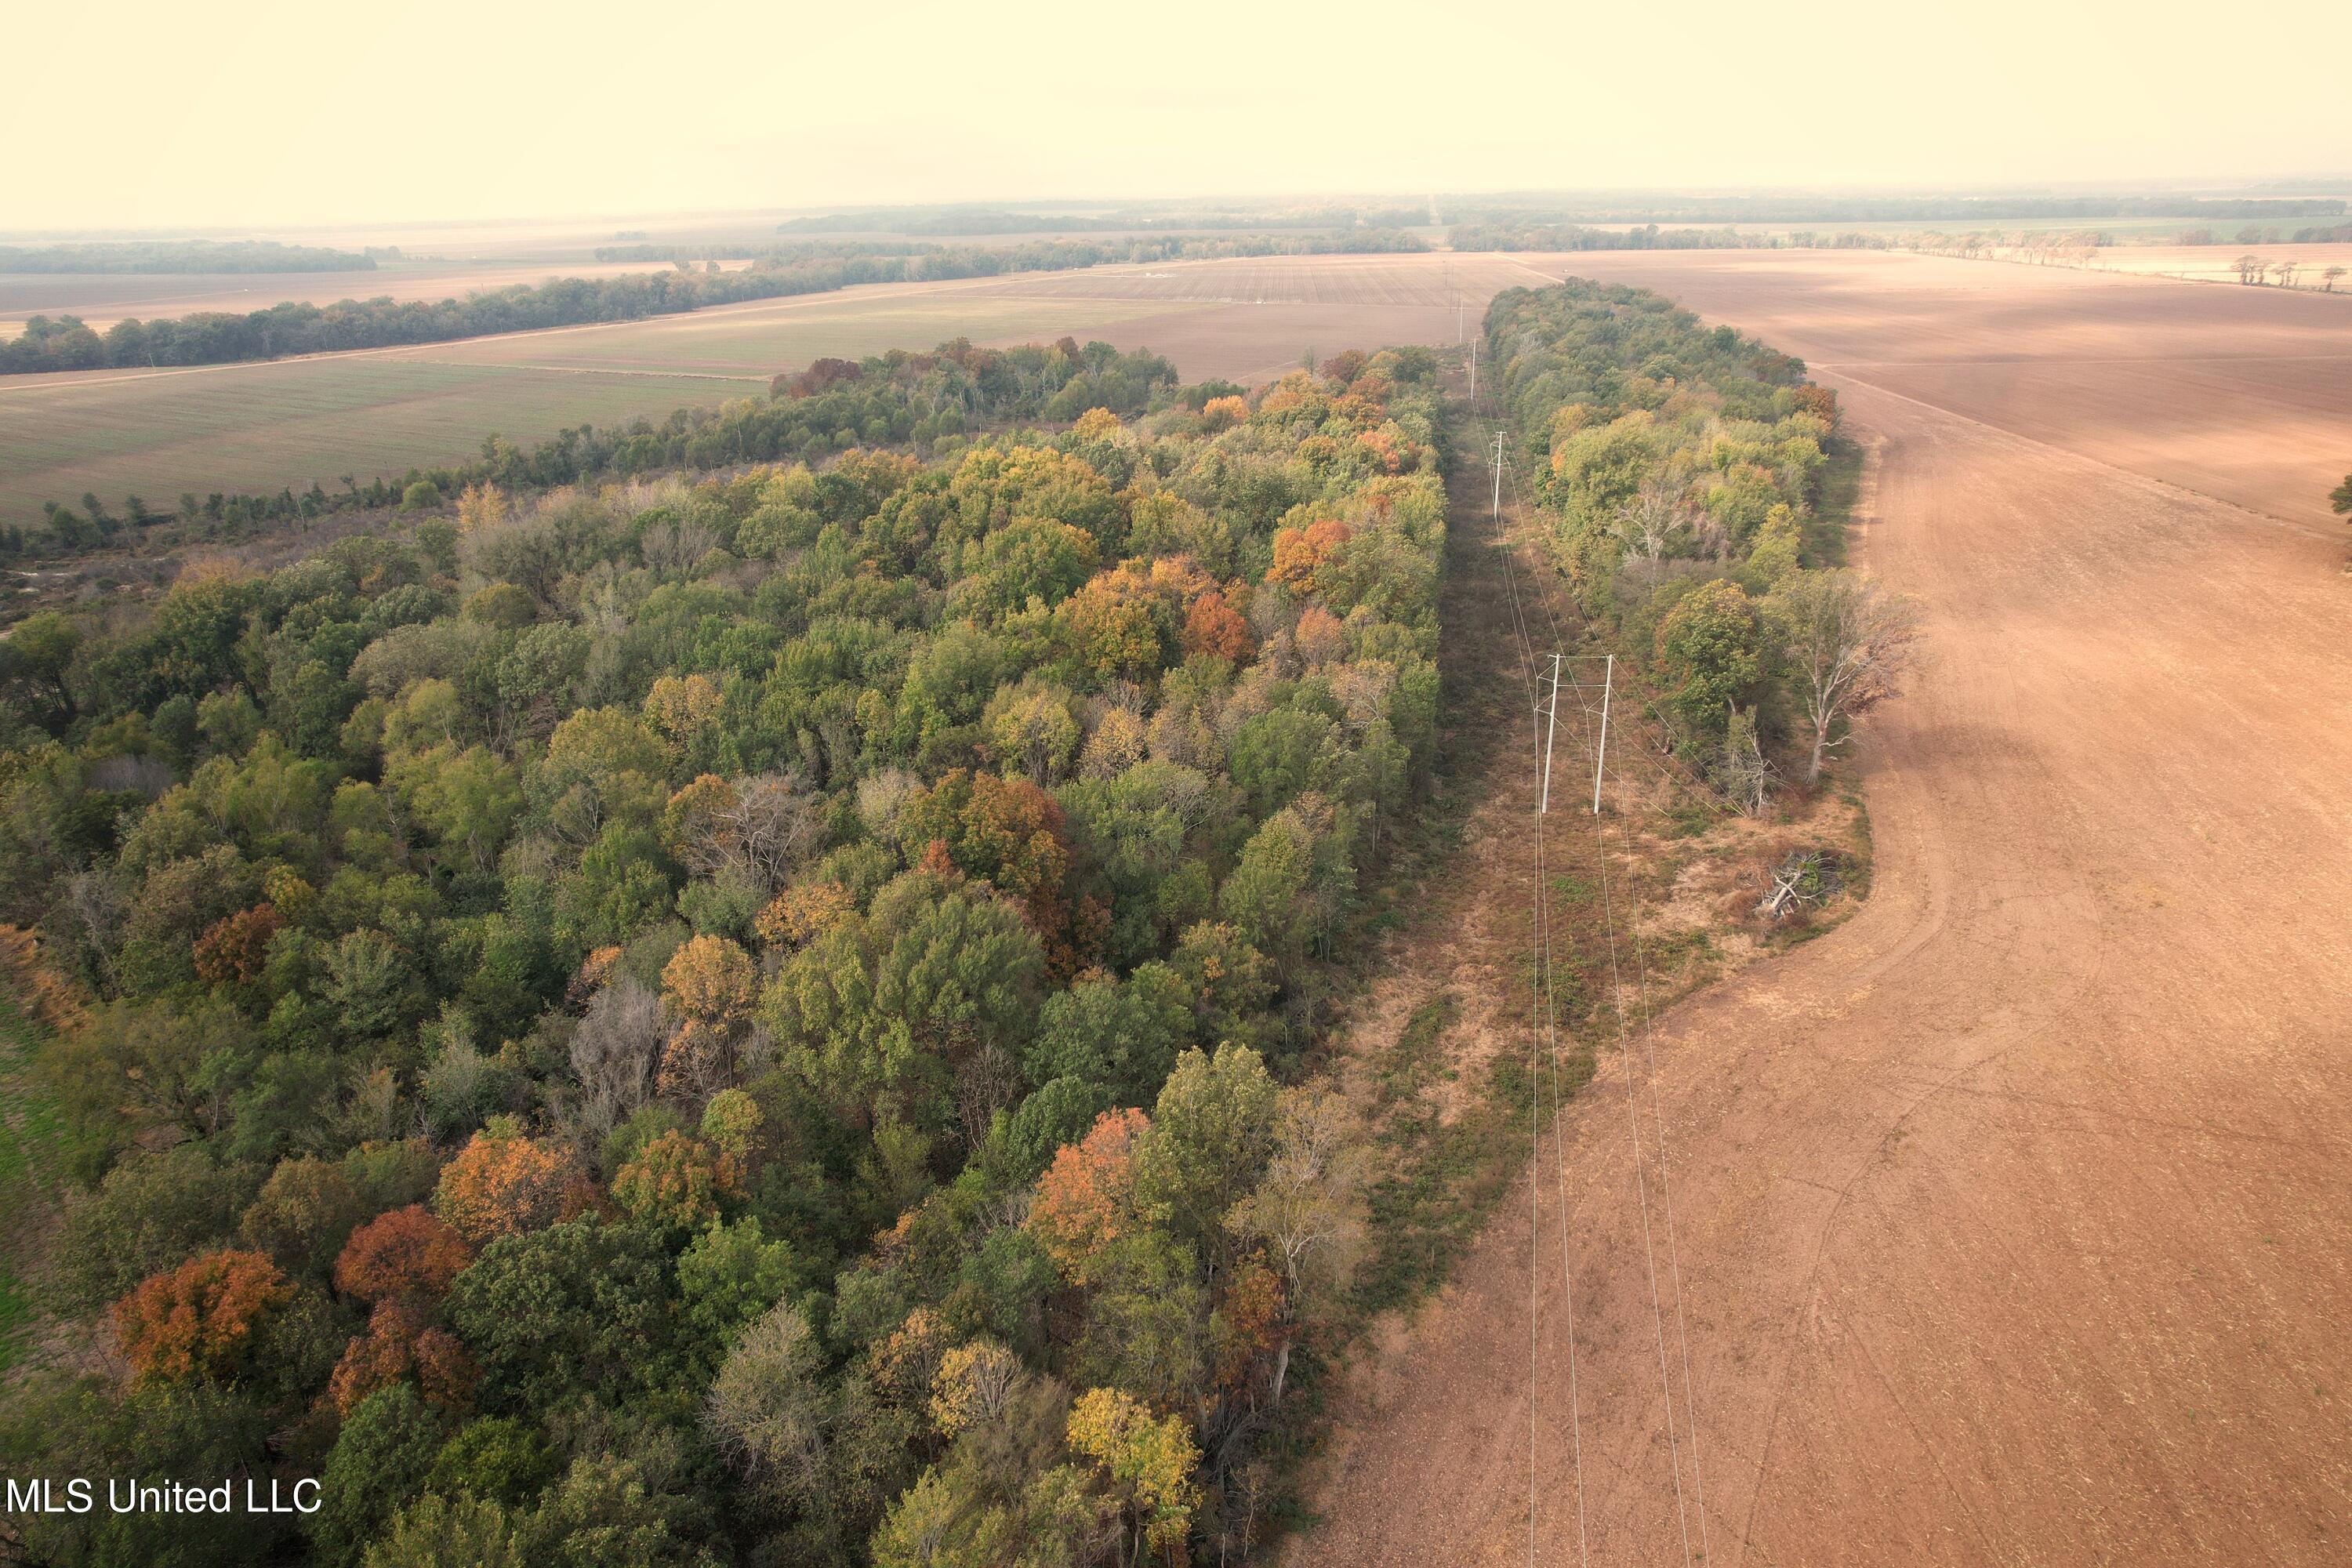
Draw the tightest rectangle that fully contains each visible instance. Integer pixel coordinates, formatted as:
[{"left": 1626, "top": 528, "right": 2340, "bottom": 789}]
[{"left": 0, "top": 285, "right": 1197, "bottom": 522}]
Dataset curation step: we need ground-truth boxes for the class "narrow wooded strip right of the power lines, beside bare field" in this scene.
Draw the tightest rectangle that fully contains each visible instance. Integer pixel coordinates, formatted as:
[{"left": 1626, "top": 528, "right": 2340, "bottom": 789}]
[{"left": 1486, "top": 278, "right": 1915, "bottom": 811}]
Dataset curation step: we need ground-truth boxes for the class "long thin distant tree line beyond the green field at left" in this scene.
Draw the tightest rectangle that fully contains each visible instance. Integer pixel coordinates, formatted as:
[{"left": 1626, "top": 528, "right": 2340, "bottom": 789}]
[{"left": 0, "top": 230, "right": 1428, "bottom": 376}]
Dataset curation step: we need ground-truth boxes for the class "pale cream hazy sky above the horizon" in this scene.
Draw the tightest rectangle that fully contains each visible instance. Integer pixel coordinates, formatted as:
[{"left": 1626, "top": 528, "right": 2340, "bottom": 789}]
[{"left": 0, "top": 0, "right": 2352, "bottom": 230}]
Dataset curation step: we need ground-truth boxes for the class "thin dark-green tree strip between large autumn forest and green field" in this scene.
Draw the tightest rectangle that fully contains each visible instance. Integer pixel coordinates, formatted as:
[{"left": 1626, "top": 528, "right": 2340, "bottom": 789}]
[{"left": 13, "top": 339, "right": 1195, "bottom": 560}]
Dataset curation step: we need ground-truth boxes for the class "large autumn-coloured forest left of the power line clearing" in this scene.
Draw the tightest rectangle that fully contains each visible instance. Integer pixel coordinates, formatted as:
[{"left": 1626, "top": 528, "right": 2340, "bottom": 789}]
[{"left": 0, "top": 346, "right": 1458, "bottom": 1568}]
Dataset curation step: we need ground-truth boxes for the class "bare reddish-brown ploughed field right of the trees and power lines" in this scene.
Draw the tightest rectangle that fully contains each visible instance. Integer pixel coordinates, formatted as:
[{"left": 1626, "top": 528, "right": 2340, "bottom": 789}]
[{"left": 1289, "top": 256, "right": 2352, "bottom": 1566}]
